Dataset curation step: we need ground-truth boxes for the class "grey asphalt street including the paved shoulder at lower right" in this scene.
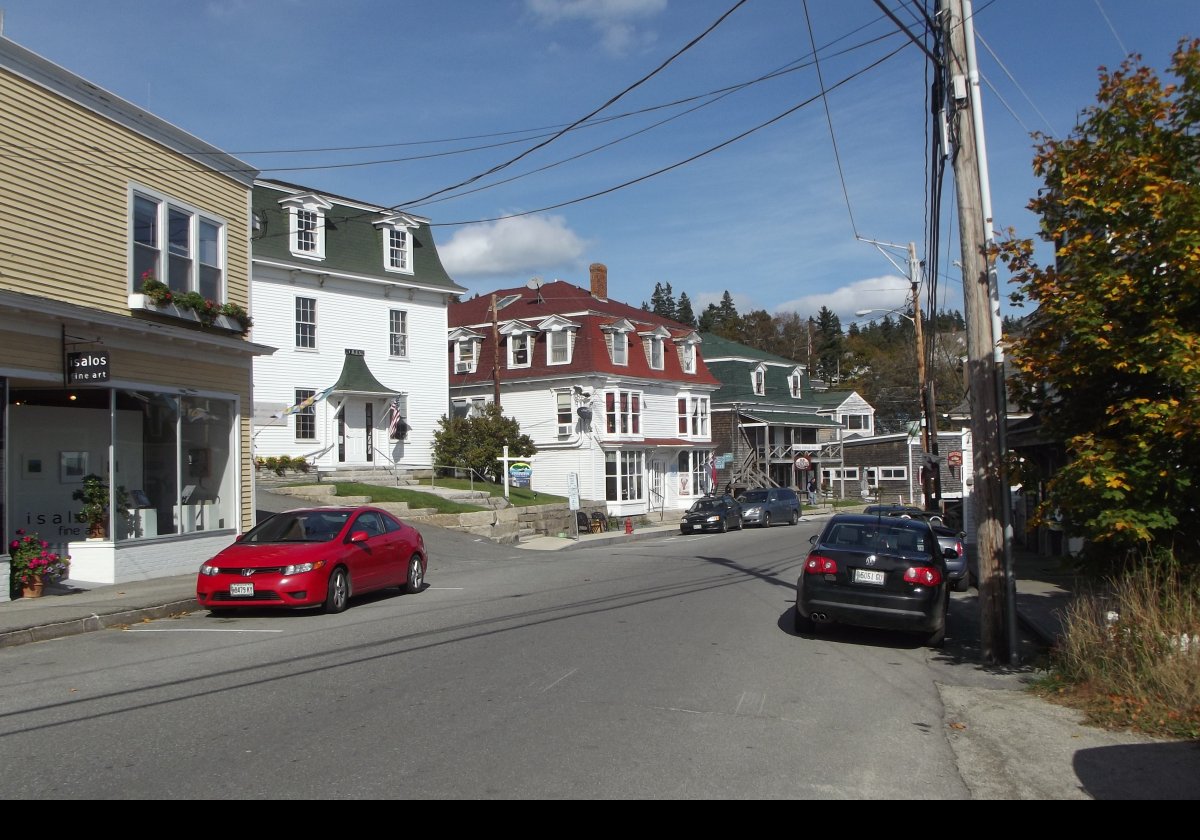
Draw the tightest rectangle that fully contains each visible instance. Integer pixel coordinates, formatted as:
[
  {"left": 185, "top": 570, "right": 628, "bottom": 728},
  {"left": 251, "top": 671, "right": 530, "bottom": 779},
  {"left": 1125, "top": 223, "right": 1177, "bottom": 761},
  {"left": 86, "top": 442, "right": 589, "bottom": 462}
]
[{"left": 0, "top": 524, "right": 1200, "bottom": 800}]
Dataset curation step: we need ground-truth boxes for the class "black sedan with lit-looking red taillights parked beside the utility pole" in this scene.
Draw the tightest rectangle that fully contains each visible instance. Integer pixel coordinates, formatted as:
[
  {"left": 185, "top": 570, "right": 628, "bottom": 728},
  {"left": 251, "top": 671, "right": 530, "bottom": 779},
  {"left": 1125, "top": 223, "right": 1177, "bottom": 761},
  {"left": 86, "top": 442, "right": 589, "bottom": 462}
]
[{"left": 794, "top": 514, "right": 953, "bottom": 647}]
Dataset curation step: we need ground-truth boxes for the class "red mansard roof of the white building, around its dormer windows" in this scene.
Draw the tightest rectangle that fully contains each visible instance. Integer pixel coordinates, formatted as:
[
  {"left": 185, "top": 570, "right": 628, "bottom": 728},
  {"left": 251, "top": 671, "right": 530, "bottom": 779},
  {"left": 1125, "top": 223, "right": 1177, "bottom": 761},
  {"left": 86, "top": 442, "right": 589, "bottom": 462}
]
[{"left": 448, "top": 280, "right": 720, "bottom": 386}]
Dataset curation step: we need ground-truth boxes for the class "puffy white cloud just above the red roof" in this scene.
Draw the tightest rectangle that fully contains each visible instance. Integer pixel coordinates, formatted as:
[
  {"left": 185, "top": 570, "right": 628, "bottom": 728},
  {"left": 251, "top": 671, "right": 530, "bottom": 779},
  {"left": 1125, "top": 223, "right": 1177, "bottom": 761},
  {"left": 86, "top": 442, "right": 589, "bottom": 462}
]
[{"left": 438, "top": 216, "right": 588, "bottom": 278}]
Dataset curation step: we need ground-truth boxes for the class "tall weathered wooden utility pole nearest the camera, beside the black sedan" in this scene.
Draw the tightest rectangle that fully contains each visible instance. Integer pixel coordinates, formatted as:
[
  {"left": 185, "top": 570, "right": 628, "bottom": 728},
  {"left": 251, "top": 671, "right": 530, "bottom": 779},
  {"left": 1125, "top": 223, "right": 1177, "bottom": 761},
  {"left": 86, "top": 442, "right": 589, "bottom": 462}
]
[{"left": 937, "top": 0, "right": 1013, "bottom": 662}]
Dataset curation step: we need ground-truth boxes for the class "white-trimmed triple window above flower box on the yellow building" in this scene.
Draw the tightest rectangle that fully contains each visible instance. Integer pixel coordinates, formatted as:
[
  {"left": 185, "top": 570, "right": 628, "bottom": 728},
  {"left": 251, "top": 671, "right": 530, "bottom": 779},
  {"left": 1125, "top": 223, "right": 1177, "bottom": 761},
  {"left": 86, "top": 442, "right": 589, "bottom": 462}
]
[{"left": 130, "top": 187, "right": 227, "bottom": 304}]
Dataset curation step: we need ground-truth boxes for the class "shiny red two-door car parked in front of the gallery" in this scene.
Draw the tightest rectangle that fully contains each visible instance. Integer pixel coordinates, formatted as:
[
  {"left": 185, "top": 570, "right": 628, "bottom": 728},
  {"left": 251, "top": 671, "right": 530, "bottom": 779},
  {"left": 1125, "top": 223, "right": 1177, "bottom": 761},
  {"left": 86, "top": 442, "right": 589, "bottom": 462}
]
[{"left": 196, "top": 506, "right": 428, "bottom": 612}]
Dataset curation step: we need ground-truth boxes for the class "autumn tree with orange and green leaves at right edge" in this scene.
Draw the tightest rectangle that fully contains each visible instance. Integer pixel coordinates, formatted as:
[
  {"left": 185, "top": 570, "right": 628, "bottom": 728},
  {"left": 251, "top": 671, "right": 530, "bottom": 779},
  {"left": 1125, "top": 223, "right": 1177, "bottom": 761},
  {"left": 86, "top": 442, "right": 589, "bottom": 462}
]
[{"left": 997, "top": 41, "right": 1200, "bottom": 573}]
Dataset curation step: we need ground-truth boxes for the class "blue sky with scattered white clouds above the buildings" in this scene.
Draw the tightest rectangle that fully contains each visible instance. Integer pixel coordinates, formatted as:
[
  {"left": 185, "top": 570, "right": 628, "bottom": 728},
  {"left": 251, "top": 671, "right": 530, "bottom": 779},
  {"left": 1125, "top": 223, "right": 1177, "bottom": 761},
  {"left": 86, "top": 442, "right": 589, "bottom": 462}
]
[{"left": 0, "top": 0, "right": 1200, "bottom": 325}]
